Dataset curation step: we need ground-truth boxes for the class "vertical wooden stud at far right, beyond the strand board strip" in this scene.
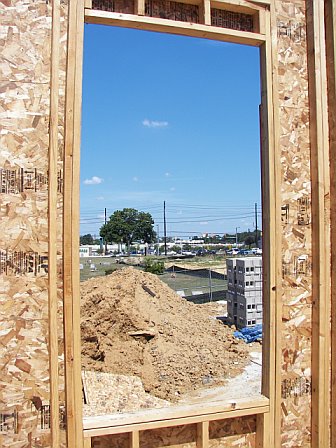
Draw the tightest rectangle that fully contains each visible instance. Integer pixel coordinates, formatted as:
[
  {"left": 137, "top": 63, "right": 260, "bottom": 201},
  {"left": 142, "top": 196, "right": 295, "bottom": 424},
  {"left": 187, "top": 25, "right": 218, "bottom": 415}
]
[{"left": 307, "top": 0, "right": 330, "bottom": 448}]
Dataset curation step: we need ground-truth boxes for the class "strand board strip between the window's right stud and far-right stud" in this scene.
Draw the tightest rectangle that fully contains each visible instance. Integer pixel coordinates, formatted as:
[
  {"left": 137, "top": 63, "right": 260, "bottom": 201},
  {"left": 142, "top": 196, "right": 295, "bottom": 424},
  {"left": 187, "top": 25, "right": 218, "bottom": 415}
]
[{"left": 276, "top": 0, "right": 312, "bottom": 447}]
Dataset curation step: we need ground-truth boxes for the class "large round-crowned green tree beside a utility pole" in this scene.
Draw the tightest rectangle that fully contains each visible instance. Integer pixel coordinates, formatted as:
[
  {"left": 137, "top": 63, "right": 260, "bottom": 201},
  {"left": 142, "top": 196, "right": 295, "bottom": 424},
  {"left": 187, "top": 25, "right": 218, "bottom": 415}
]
[{"left": 100, "top": 208, "right": 156, "bottom": 251}]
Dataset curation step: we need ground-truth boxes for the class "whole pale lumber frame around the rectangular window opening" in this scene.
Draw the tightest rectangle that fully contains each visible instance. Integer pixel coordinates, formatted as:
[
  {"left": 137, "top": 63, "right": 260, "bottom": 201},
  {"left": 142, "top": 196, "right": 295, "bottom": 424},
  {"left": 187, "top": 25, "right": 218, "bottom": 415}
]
[{"left": 63, "top": 0, "right": 281, "bottom": 448}]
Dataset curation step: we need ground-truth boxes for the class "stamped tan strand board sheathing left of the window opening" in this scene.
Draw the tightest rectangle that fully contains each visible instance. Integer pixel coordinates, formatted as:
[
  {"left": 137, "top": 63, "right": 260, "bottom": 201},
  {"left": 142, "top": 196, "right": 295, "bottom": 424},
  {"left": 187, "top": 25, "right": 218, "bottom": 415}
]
[{"left": 0, "top": 0, "right": 66, "bottom": 447}]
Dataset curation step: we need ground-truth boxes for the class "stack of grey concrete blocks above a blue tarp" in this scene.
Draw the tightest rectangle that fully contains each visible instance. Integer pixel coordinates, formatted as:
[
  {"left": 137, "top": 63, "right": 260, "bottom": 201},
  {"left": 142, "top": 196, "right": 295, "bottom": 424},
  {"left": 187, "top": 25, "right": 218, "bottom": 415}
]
[{"left": 226, "top": 257, "right": 262, "bottom": 328}]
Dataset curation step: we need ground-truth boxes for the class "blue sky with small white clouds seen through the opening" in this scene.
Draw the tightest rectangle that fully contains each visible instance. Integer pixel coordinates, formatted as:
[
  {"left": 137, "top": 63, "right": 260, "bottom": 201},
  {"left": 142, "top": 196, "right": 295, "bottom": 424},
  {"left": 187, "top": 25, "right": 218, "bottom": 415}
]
[{"left": 81, "top": 25, "right": 261, "bottom": 240}]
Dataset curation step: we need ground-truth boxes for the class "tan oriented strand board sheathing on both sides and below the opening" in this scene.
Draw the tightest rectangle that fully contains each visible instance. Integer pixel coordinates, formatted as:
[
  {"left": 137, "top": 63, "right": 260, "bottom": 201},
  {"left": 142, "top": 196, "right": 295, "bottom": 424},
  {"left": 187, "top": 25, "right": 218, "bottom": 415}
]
[{"left": 0, "top": 0, "right": 334, "bottom": 448}]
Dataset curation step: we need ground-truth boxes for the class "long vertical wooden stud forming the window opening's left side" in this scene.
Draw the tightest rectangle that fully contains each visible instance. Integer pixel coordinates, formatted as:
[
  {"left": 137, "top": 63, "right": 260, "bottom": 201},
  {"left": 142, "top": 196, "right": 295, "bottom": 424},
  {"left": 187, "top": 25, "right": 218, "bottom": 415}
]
[{"left": 63, "top": 0, "right": 84, "bottom": 448}]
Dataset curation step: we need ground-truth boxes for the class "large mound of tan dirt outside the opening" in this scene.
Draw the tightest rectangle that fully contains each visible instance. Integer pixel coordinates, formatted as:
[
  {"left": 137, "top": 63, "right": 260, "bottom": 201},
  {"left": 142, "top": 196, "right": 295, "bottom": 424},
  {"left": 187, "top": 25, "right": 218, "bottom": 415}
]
[{"left": 81, "top": 267, "right": 249, "bottom": 401}]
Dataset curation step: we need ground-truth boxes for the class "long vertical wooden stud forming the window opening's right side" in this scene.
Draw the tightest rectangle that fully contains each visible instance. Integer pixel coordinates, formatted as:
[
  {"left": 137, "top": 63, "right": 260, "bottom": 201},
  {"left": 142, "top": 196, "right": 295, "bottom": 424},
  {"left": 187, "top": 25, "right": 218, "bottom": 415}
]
[{"left": 260, "top": 5, "right": 282, "bottom": 444}]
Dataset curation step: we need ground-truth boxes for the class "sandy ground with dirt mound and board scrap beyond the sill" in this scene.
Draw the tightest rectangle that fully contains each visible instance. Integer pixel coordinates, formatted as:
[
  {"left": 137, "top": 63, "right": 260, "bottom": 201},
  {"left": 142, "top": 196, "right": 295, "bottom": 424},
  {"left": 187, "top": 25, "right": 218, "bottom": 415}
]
[{"left": 81, "top": 267, "right": 261, "bottom": 415}]
